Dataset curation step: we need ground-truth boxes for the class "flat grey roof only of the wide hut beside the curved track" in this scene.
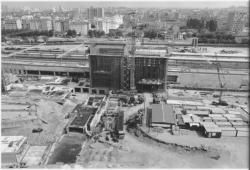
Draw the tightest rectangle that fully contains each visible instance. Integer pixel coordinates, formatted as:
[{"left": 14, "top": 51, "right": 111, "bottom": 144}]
[{"left": 152, "top": 103, "right": 177, "bottom": 124}]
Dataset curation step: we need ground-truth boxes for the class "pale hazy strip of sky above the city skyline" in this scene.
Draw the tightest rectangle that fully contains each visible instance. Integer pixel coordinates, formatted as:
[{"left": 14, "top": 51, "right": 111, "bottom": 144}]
[{"left": 2, "top": 0, "right": 248, "bottom": 8}]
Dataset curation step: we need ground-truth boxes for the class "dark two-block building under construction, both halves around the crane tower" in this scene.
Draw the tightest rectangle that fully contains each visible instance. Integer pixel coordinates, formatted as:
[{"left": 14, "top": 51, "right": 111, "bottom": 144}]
[{"left": 89, "top": 42, "right": 170, "bottom": 91}]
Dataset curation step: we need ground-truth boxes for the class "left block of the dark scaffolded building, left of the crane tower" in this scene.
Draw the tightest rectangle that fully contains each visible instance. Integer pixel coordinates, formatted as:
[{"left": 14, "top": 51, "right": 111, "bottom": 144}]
[{"left": 89, "top": 42, "right": 126, "bottom": 93}]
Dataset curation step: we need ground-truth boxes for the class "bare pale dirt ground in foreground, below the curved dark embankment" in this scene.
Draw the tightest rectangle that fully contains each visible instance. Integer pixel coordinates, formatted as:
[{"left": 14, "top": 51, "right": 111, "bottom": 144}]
[{"left": 76, "top": 129, "right": 248, "bottom": 168}]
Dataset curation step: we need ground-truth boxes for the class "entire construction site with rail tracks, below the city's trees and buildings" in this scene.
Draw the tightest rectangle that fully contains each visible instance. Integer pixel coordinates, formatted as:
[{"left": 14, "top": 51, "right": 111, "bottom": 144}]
[{"left": 1, "top": 18, "right": 249, "bottom": 168}]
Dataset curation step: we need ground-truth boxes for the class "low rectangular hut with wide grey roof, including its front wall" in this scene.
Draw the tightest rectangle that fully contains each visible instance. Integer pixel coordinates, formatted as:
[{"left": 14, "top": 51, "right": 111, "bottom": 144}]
[{"left": 147, "top": 103, "right": 177, "bottom": 128}]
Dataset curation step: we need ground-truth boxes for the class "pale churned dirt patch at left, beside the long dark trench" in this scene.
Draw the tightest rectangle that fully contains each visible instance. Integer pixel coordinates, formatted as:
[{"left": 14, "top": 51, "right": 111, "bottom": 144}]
[{"left": 1, "top": 81, "right": 88, "bottom": 145}]
